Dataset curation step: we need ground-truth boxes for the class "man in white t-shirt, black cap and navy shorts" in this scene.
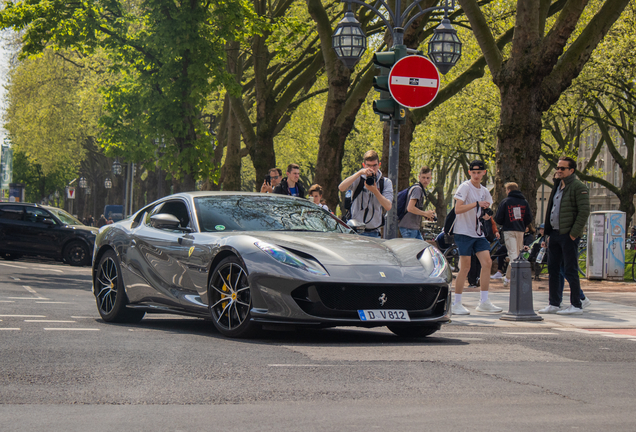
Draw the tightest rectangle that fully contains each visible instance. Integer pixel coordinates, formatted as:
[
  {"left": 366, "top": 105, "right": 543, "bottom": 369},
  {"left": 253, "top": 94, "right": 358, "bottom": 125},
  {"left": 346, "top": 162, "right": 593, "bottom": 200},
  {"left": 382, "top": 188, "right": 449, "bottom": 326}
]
[{"left": 452, "top": 160, "right": 503, "bottom": 315}]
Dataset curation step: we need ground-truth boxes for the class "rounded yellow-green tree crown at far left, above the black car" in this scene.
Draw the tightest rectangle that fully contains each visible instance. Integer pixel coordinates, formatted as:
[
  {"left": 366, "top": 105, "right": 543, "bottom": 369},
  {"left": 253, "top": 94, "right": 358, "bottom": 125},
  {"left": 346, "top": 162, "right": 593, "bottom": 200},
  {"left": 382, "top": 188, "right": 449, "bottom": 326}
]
[{"left": 5, "top": 50, "right": 101, "bottom": 175}]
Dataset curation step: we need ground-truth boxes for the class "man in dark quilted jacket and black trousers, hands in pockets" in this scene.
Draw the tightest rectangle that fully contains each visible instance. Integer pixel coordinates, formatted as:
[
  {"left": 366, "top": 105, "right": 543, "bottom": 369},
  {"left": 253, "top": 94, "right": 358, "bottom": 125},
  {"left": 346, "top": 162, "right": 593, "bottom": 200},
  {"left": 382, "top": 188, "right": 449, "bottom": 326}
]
[{"left": 539, "top": 157, "right": 590, "bottom": 315}]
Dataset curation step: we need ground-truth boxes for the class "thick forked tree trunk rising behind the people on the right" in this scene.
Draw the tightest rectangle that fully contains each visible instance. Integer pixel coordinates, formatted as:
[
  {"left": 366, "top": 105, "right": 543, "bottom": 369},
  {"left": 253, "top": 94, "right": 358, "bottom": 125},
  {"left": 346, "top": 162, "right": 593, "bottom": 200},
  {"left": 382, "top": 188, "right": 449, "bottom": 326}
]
[{"left": 459, "top": 0, "right": 629, "bottom": 208}]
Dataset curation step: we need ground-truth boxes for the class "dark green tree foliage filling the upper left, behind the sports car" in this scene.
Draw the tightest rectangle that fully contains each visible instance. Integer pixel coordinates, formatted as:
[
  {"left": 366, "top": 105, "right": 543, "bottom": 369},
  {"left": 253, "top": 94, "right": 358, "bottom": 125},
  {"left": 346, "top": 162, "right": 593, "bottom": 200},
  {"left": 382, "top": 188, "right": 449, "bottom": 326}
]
[{"left": 0, "top": 0, "right": 251, "bottom": 189}]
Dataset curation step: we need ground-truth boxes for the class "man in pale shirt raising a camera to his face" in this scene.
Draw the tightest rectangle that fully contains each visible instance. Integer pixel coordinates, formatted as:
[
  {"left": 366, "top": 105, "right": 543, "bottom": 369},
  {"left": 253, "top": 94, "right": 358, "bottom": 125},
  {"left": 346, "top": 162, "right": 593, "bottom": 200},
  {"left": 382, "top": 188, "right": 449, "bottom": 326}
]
[{"left": 338, "top": 150, "right": 393, "bottom": 237}]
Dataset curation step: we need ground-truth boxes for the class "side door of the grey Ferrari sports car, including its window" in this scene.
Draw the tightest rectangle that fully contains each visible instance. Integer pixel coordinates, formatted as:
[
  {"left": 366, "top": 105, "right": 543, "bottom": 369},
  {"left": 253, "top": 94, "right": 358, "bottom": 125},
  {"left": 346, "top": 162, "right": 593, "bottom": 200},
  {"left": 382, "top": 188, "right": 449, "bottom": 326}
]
[{"left": 129, "top": 199, "right": 205, "bottom": 308}]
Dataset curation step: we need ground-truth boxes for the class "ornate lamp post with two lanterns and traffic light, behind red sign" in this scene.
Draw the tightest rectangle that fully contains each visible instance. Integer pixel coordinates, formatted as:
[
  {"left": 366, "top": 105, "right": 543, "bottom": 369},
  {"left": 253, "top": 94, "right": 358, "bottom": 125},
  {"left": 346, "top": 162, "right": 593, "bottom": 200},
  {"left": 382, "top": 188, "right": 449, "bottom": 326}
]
[{"left": 331, "top": 0, "right": 462, "bottom": 239}]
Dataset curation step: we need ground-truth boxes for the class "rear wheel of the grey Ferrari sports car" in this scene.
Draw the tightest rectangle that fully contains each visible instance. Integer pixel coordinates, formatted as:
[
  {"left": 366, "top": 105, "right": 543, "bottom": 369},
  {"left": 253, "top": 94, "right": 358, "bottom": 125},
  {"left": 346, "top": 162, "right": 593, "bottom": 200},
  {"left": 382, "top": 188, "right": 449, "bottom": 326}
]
[{"left": 94, "top": 250, "right": 146, "bottom": 323}]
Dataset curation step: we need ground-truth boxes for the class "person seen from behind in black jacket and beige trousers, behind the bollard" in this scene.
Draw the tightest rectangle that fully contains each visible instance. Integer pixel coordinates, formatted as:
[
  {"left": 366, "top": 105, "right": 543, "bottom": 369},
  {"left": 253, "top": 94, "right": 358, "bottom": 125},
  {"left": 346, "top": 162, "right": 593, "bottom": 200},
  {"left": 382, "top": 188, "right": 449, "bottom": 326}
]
[{"left": 495, "top": 182, "right": 532, "bottom": 286}]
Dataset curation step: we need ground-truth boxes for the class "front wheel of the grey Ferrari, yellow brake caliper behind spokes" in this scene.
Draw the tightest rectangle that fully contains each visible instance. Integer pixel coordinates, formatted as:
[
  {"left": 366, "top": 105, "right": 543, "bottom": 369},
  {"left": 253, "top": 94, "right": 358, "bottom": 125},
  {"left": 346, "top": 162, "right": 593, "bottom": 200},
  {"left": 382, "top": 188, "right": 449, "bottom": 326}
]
[{"left": 208, "top": 256, "right": 259, "bottom": 338}]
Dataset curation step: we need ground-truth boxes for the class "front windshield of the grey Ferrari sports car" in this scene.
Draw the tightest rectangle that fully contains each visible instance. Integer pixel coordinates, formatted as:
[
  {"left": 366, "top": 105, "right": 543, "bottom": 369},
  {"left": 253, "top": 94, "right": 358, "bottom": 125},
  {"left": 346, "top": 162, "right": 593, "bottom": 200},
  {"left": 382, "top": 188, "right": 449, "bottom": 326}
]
[{"left": 195, "top": 195, "right": 353, "bottom": 233}]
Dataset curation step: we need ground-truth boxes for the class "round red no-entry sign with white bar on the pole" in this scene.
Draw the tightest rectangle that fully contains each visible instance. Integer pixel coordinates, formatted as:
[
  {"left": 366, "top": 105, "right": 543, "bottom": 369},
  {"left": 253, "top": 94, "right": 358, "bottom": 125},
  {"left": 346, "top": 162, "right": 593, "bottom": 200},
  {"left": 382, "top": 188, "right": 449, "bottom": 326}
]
[{"left": 389, "top": 55, "right": 440, "bottom": 108}]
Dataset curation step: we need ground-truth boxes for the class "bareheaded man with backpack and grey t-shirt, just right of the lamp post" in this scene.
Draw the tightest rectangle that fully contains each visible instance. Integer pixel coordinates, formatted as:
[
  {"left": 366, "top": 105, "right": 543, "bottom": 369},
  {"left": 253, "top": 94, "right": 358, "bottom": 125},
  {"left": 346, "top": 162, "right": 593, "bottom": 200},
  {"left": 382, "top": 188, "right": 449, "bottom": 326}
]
[{"left": 397, "top": 166, "right": 435, "bottom": 240}]
